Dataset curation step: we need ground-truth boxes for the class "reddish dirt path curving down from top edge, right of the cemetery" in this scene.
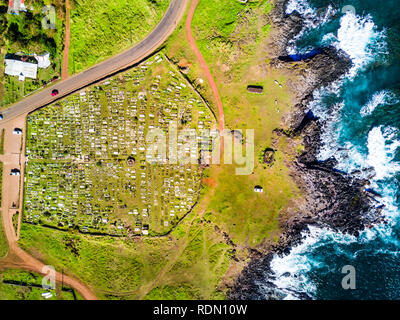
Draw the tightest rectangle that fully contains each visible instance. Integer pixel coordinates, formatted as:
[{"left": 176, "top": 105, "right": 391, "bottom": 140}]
[{"left": 185, "top": 0, "right": 225, "bottom": 132}]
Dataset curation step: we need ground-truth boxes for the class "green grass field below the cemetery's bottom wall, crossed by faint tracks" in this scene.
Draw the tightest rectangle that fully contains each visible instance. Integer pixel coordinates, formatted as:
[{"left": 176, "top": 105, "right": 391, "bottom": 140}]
[{"left": 19, "top": 206, "right": 231, "bottom": 299}]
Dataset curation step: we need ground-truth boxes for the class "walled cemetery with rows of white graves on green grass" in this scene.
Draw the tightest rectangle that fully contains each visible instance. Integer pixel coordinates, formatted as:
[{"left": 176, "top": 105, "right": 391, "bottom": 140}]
[{"left": 24, "top": 53, "right": 216, "bottom": 236}]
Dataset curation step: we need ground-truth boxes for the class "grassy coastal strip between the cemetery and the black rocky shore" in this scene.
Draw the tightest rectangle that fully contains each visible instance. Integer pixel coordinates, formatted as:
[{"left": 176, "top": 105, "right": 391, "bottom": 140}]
[{"left": 167, "top": 0, "right": 299, "bottom": 246}]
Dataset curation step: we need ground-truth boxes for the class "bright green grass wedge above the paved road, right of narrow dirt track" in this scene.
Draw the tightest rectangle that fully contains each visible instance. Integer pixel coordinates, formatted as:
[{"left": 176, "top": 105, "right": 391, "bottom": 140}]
[{"left": 68, "top": 0, "right": 170, "bottom": 74}]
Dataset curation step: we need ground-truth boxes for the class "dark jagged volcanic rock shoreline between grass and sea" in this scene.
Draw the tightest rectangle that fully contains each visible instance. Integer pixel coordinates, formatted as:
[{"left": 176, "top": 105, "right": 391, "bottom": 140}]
[{"left": 228, "top": 0, "right": 381, "bottom": 300}]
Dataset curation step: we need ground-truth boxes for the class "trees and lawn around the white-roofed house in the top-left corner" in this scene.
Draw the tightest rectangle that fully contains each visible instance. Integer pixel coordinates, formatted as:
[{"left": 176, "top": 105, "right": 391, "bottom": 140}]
[{"left": 0, "top": 0, "right": 64, "bottom": 107}]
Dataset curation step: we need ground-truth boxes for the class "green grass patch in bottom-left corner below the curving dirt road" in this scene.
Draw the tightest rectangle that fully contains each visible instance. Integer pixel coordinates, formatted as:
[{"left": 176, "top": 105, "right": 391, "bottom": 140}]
[{"left": 0, "top": 269, "right": 82, "bottom": 300}]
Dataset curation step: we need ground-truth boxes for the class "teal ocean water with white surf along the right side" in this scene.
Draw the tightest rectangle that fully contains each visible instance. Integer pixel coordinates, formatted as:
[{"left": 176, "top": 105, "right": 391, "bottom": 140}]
[{"left": 261, "top": 0, "right": 400, "bottom": 299}]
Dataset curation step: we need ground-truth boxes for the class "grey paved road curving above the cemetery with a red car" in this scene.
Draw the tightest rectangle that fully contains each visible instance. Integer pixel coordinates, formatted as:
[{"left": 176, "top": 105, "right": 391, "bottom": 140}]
[{"left": 1, "top": 0, "right": 187, "bottom": 122}]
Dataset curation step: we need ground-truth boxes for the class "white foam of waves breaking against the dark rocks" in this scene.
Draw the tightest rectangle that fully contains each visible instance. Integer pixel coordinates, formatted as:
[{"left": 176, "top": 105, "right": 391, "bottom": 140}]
[{"left": 270, "top": 0, "right": 400, "bottom": 299}]
